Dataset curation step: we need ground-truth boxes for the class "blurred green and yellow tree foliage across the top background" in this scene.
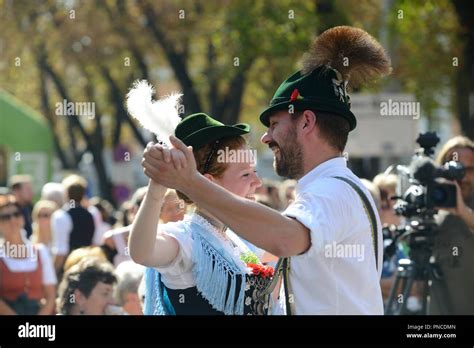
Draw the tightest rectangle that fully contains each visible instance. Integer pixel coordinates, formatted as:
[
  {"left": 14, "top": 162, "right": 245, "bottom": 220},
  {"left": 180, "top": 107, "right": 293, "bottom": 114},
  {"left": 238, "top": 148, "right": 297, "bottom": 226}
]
[{"left": 0, "top": 0, "right": 462, "bottom": 150}]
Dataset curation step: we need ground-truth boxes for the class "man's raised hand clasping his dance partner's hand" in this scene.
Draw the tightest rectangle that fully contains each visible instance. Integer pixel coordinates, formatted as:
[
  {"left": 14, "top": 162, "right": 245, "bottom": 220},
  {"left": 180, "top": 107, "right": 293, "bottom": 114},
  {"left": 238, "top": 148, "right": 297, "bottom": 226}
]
[{"left": 142, "top": 136, "right": 199, "bottom": 192}]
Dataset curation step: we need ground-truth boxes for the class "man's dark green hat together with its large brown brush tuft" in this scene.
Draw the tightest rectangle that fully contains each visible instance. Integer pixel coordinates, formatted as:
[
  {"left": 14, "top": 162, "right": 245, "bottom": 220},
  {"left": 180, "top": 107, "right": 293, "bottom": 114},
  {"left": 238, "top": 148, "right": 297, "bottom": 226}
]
[{"left": 260, "top": 26, "right": 391, "bottom": 130}]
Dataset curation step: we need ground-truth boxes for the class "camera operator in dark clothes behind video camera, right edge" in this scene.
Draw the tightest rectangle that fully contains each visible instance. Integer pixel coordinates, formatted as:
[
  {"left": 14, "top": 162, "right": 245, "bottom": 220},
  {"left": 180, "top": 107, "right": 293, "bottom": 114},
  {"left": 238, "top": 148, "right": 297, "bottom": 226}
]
[{"left": 429, "top": 136, "right": 474, "bottom": 314}]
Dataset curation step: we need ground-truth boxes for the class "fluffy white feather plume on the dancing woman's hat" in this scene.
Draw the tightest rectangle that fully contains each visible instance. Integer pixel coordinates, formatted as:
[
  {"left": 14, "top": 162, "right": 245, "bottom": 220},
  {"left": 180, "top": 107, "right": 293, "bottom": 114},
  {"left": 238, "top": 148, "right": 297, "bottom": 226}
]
[{"left": 126, "top": 80, "right": 183, "bottom": 146}]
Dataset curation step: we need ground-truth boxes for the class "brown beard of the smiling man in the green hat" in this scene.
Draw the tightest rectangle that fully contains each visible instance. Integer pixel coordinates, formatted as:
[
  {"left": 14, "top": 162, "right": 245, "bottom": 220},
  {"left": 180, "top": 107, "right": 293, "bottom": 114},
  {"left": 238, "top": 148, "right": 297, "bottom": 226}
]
[{"left": 268, "top": 127, "right": 303, "bottom": 179}]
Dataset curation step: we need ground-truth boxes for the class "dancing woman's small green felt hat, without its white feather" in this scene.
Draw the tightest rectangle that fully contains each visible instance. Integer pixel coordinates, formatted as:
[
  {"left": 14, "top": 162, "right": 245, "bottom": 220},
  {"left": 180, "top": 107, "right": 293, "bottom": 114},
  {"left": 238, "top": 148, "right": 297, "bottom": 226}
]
[{"left": 175, "top": 112, "right": 250, "bottom": 149}]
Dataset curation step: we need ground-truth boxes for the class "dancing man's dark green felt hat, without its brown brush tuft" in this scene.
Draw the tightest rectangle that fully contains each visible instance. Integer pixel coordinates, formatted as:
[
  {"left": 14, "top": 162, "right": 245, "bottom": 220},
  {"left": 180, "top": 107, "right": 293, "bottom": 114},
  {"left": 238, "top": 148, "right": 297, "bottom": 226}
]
[{"left": 260, "top": 65, "right": 357, "bottom": 130}]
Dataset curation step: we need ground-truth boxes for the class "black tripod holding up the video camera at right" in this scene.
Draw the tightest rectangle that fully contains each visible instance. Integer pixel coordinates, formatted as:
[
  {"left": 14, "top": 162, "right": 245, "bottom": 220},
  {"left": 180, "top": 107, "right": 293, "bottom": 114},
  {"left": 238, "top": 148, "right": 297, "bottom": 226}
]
[{"left": 385, "top": 221, "right": 442, "bottom": 315}]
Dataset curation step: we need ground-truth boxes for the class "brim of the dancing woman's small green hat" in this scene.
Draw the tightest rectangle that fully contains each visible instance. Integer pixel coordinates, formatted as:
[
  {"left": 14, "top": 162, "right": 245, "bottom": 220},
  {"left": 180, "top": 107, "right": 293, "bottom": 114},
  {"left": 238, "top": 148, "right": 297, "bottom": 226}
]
[{"left": 182, "top": 123, "right": 250, "bottom": 149}]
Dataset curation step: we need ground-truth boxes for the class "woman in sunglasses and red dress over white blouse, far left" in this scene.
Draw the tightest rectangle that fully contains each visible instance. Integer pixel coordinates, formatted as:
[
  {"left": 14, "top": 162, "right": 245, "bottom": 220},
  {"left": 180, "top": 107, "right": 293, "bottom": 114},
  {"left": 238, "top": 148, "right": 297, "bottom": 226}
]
[{"left": 0, "top": 195, "right": 57, "bottom": 315}]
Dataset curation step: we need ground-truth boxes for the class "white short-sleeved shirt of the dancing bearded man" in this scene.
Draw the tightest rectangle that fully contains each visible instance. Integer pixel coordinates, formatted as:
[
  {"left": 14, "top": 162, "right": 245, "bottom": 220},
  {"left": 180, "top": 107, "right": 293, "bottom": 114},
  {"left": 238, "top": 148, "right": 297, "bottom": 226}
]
[{"left": 273, "top": 157, "right": 383, "bottom": 315}]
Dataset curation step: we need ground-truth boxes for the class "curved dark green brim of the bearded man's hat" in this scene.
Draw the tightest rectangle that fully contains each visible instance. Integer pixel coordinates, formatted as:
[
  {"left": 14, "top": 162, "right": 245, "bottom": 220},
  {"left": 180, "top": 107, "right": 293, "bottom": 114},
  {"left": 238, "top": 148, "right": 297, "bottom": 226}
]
[{"left": 260, "top": 100, "right": 357, "bottom": 131}]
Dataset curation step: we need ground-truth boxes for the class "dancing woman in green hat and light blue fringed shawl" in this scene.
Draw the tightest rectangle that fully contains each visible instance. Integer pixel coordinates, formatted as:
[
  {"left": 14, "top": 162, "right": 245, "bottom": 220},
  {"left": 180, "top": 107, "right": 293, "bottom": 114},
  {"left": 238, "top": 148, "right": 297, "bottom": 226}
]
[{"left": 128, "top": 113, "right": 278, "bottom": 315}]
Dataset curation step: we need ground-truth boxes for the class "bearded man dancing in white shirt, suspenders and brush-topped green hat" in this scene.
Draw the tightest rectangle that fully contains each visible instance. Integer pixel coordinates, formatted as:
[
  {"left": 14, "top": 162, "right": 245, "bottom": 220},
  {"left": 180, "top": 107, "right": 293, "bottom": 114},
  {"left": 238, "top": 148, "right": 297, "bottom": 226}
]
[{"left": 143, "top": 27, "right": 390, "bottom": 315}]
